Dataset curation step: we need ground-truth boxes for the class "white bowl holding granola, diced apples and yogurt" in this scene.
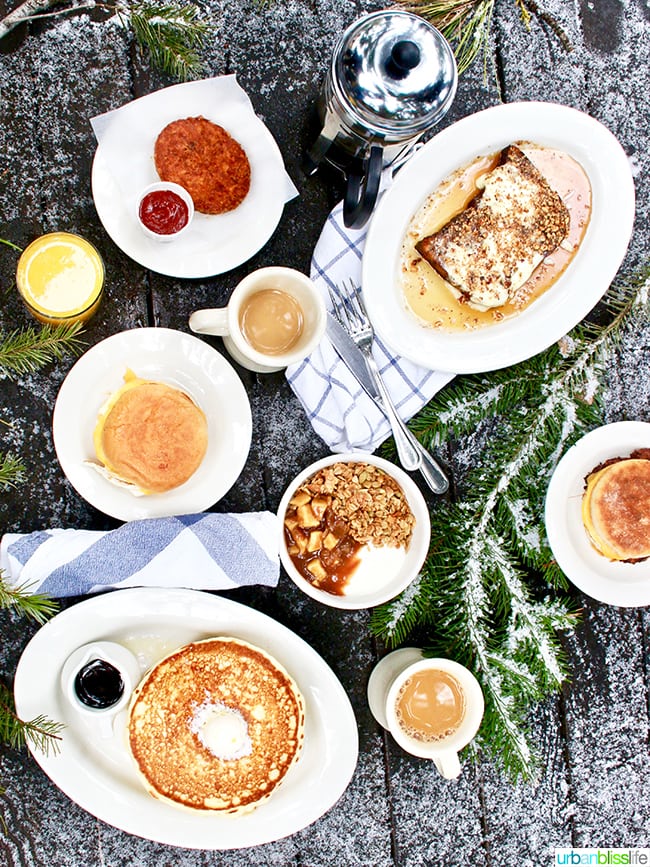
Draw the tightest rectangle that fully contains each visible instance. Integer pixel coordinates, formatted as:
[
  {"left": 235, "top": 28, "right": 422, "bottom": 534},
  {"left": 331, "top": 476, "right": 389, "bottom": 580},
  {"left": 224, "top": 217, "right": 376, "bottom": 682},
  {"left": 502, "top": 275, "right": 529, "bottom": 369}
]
[{"left": 277, "top": 452, "right": 431, "bottom": 609}]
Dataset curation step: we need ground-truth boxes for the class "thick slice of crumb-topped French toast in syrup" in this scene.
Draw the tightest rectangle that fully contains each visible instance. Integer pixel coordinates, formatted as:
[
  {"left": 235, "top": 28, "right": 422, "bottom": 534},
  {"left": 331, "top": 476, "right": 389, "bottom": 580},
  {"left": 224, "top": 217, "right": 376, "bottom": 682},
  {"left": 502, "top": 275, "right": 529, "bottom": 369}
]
[{"left": 415, "top": 145, "right": 570, "bottom": 310}]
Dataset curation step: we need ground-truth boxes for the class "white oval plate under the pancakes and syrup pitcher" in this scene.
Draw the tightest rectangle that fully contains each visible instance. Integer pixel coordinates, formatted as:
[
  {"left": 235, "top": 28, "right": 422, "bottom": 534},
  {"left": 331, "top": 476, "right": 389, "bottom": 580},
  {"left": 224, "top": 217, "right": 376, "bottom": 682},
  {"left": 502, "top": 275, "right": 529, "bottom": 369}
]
[{"left": 14, "top": 588, "right": 358, "bottom": 849}]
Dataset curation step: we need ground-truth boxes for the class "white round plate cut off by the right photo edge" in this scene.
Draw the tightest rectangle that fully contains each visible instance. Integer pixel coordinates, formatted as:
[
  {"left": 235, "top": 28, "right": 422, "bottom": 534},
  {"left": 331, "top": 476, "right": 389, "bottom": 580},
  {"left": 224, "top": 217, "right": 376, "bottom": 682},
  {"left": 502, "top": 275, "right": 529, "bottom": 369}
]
[{"left": 546, "top": 421, "right": 650, "bottom": 607}]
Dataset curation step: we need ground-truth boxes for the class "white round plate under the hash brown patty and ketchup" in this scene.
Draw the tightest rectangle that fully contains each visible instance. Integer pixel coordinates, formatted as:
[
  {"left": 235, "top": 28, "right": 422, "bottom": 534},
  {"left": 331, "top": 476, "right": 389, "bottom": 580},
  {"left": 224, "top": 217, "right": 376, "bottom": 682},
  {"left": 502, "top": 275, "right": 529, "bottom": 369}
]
[{"left": 91, "top": 92, "right": 291, "bottom": 278}]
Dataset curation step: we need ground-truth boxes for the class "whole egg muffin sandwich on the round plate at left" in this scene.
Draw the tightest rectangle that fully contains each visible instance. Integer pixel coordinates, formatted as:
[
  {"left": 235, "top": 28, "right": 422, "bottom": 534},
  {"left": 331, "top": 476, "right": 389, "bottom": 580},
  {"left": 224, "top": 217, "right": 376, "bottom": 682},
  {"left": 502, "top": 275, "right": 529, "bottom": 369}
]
[{"left": 93, "top": 370, "right": 208, "bottom": 494}]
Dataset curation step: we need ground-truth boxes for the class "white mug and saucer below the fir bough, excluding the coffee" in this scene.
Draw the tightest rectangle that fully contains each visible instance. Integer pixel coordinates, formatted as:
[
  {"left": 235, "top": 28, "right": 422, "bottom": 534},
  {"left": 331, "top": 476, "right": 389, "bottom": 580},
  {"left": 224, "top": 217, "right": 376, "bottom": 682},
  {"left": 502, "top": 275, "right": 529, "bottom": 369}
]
[{"left": 368, "top": 647, "right": 484, "bottom": 779}]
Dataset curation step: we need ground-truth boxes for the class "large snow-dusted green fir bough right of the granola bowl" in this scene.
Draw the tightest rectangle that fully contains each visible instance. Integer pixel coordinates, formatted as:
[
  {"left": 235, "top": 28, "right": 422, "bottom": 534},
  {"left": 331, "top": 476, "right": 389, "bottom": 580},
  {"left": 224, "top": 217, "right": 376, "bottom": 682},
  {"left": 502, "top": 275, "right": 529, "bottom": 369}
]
[{"left": 372, "top": 269, "right": 650, "bottom": 778}]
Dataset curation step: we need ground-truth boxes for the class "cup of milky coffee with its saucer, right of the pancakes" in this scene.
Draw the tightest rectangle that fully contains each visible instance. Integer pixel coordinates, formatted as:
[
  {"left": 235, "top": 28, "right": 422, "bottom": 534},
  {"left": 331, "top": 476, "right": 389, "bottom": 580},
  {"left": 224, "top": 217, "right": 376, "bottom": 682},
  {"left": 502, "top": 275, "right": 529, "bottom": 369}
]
[{"left": 368, "top": 647, "right": 484, "bottom": 779}]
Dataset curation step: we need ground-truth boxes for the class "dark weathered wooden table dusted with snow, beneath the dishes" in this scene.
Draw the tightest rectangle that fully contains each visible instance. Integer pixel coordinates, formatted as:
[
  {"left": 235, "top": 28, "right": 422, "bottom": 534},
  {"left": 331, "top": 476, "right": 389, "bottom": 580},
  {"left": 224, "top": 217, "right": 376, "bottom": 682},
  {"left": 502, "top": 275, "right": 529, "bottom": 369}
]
[{"left": 0, "top": 0, "right": 650, "bottom": 867}]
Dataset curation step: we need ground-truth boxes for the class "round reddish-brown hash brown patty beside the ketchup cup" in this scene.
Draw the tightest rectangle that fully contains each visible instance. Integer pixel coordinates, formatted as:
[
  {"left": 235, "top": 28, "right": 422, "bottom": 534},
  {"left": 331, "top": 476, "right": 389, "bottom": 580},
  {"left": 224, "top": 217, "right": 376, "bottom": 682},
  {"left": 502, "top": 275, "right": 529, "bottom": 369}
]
[{"left": 154, "top": 117, "right": 251, "bottom": 214}]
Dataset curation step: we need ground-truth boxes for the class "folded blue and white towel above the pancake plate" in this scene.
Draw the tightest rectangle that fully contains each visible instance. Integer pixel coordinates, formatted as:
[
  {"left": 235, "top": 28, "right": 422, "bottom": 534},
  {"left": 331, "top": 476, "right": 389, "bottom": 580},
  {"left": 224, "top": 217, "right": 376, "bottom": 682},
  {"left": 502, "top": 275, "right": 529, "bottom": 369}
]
[{"left": 0, "top": 512, "right": 280, "bottom": 597}]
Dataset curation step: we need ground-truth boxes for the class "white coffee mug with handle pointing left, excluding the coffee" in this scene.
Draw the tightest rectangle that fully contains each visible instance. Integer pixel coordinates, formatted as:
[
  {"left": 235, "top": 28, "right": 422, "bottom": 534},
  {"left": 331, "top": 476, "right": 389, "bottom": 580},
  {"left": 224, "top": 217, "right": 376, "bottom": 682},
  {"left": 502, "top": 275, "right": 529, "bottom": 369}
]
[{"left": 189, "top": 267, "right": 326, "bottom": 373}]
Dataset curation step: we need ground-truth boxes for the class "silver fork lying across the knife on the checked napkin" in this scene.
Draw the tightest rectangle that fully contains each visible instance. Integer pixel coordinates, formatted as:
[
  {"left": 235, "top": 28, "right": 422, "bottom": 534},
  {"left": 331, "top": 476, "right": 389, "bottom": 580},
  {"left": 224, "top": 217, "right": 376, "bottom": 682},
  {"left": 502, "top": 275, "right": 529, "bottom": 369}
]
[{"left": 330, "top": 281, "right": 449, "bottom": 494}]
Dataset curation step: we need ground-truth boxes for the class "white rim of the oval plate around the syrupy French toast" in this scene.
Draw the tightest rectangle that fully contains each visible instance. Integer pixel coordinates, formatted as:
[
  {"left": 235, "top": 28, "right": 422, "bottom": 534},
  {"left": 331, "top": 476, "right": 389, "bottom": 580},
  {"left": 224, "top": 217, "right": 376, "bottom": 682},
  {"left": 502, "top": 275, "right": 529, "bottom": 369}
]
[{"left": 362, "top": 102, "right": 634, "bottom": 373}]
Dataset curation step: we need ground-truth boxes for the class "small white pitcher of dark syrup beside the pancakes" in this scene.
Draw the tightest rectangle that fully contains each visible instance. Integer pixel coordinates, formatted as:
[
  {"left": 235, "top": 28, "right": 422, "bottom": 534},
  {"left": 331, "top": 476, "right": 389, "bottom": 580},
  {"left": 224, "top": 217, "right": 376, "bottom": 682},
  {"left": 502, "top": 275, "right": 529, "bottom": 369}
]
[{"left": 61, "top": 641, "right": 142, "bottom": 732}]
